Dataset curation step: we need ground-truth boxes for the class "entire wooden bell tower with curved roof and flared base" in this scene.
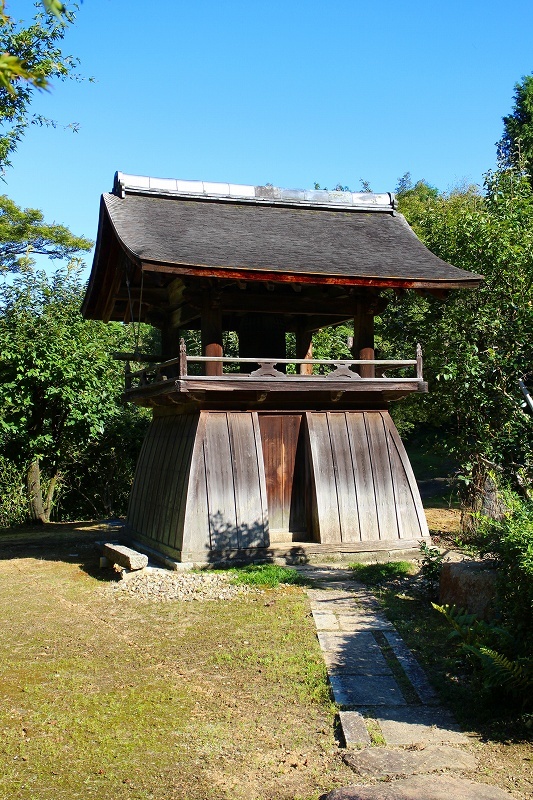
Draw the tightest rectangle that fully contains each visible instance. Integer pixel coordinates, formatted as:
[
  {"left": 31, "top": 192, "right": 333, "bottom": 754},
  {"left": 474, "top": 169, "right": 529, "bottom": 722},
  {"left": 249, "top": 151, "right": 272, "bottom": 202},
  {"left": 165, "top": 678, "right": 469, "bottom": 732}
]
[{"left": 83, "top": 173, "right": 481, "bottom": 563}]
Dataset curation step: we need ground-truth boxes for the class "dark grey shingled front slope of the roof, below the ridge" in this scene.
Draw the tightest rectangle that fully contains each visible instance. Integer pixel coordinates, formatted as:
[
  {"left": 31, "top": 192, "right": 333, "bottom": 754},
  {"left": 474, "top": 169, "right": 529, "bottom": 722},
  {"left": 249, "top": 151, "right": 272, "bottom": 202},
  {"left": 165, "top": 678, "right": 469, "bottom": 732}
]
[{"left": 97, "top": 194, "right": 481, "bottom": 288}]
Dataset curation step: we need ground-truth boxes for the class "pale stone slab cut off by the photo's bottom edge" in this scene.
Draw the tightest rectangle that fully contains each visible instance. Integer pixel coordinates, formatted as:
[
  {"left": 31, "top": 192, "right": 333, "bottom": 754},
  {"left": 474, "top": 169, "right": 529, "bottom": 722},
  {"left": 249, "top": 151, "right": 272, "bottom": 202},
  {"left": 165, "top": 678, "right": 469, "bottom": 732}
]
[{"left": 324, "top": 775, "right": 513, "bottom": 800}]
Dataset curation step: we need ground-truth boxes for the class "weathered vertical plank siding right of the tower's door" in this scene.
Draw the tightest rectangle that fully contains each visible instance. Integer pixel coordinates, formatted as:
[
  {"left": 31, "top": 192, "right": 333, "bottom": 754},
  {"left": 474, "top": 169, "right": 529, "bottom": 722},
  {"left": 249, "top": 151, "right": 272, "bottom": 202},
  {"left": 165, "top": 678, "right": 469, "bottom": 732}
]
[{"left": 307, "top": 411, "right": 429, "bottom": 543}]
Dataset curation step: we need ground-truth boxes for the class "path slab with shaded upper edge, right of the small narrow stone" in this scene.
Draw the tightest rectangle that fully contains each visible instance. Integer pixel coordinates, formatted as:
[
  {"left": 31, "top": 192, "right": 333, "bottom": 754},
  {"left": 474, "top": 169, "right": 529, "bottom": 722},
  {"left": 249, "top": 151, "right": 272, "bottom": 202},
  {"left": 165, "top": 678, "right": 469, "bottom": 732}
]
[{"left": 375, "top": 706, "right": 468, "bottom": 745}]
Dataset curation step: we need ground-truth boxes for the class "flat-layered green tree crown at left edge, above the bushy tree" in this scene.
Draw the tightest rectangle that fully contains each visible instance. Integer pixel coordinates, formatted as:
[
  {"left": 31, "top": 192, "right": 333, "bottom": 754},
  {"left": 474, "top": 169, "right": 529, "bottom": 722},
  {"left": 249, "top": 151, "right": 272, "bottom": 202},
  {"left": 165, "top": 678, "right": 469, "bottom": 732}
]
[{"left": 0, "top": 195, "right": 92, "bottom": 272}]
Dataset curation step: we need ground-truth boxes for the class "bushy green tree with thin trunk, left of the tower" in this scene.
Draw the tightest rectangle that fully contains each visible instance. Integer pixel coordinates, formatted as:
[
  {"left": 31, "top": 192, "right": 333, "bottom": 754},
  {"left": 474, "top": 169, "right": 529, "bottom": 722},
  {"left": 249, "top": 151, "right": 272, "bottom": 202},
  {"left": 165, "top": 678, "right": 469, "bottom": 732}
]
[{"left": 0, "top": 266, "right": 148, "bottom": 522}]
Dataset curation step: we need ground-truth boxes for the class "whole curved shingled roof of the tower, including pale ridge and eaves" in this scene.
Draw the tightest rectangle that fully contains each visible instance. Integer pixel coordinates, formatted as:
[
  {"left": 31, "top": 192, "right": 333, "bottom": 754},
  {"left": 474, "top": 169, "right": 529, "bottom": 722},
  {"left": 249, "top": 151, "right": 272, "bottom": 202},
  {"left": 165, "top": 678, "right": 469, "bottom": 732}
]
[{"left": 82, "top": 173, "right": 482, "bottom": 319}]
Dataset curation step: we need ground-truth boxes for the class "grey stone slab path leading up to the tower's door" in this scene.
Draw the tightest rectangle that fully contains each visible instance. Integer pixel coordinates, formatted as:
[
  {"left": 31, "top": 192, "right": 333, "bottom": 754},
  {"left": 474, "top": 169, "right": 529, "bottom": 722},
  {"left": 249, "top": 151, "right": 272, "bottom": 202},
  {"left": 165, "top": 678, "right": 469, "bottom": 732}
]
[{"left": 298, "top": 566, "right": 512, "bottom": 800}]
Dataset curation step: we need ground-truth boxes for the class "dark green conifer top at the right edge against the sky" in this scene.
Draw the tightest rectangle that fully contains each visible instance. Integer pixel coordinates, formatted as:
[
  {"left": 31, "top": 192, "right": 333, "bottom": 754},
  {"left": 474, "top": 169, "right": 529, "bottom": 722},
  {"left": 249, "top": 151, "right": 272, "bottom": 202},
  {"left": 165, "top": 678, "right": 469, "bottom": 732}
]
[{"left": 497, "top": 75, "right": 533, "bottom": 182}]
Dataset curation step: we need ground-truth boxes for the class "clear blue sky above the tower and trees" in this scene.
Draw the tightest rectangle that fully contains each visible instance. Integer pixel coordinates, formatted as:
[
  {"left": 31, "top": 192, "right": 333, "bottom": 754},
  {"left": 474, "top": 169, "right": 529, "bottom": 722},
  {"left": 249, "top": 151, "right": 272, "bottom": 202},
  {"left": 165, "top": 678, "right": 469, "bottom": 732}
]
[{"left": 5, "top": 0, "right": 533, "bottom": 268}]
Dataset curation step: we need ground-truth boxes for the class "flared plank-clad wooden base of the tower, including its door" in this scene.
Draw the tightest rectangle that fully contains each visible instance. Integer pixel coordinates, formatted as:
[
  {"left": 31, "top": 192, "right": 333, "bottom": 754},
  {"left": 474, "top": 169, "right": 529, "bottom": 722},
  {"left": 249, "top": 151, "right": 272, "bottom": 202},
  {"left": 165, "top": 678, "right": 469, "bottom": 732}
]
[{"left": 123, "top": 410, "right": 429, "bottom": 563}]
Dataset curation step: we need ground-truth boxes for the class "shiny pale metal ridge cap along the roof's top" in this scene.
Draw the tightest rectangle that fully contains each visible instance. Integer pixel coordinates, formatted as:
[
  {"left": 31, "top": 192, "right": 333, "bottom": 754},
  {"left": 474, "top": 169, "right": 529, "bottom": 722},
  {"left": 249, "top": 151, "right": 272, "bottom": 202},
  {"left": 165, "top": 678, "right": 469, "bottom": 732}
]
[{"left": 112, "top": 172, "right": 396, "bottom": 213}]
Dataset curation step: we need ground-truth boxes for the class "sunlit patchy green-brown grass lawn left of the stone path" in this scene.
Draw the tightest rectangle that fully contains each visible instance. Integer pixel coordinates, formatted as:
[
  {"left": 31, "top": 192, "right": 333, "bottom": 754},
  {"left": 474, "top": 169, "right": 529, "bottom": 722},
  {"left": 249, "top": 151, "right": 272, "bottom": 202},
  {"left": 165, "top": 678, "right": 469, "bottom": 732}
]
[{"left": 0, "top": 526, "right": 353, "bottom": 800}]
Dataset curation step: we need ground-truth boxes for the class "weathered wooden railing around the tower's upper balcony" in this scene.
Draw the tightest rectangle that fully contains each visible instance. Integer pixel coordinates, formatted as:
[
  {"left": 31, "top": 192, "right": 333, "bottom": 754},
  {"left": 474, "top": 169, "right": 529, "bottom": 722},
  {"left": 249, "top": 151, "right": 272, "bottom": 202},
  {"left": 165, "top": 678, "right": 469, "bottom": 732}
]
[{"left": 121, "top": 340, "right": 424, "bottom": 392}]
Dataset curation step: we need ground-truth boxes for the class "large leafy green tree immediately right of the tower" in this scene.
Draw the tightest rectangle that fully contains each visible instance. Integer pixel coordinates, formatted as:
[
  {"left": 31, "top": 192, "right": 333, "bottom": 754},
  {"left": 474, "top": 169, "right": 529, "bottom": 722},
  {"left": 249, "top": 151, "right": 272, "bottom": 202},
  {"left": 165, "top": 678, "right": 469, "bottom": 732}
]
[{"left": 380, "top": 169, "right": 533, "bottom": 507}]
